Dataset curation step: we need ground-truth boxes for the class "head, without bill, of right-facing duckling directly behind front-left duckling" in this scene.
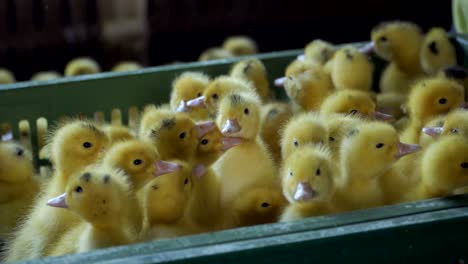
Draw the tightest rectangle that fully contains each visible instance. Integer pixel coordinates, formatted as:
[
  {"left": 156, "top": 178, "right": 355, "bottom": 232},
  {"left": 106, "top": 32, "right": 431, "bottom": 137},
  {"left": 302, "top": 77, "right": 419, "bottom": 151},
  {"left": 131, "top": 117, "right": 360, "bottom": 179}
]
[{"left": 102, "top": 139, "right": 159, "bottom": 190}]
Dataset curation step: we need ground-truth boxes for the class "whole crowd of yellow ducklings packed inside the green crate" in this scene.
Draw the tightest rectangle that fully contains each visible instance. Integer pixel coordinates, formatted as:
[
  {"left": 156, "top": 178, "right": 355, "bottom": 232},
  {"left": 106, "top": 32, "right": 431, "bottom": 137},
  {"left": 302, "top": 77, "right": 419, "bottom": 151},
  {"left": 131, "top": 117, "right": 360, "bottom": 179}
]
[{"left": 0, "top": 22, "right": 468, "bottom": 261}]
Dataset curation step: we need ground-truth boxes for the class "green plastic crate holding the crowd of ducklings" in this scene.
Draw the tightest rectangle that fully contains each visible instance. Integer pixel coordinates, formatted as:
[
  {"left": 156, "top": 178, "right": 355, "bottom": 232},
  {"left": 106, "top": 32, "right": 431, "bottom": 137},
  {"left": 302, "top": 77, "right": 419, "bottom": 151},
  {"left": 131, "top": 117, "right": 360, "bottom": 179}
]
[{"left": 0, "top": 36, "right": 468, "bottom": 264}]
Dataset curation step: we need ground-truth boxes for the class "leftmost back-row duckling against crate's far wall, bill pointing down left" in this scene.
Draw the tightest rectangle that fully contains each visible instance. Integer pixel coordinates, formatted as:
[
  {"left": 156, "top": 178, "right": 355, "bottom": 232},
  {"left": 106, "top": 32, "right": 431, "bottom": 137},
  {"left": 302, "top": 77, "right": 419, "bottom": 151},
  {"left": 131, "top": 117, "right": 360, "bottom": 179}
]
[{"left": 170, "top": 72, "right": 210, "bottom": 120}]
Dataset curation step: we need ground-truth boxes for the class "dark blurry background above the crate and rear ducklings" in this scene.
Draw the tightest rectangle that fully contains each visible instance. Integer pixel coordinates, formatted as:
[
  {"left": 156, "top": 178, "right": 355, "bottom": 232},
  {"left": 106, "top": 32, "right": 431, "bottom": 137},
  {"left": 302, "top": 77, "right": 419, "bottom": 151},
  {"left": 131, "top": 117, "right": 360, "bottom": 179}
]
[{"left": 0, "top": 0, "right": 452, "bottom": 80}]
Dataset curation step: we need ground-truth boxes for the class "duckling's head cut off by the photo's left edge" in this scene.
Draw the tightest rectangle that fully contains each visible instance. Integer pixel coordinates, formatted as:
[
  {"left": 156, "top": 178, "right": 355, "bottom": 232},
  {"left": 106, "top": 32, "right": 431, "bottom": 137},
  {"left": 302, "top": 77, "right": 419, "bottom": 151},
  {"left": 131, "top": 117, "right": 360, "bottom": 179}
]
[{"left": 0, "top": 141, "right": 34, "bottom": 183}]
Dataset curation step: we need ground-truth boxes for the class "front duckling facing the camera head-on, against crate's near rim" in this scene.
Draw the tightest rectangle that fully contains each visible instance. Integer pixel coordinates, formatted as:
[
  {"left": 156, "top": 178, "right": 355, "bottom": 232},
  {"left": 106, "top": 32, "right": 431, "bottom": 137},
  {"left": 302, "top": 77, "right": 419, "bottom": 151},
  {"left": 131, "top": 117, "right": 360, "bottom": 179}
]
[{"left": 281, "top": 144, "right": 337, "bottom": 222}]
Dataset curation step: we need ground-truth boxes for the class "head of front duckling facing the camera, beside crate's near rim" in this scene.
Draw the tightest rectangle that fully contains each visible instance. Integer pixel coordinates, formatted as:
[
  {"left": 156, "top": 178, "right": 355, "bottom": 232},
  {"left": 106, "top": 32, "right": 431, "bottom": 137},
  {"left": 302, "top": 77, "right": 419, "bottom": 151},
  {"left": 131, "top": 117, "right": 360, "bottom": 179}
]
[{"left": 281, "top": 145, "right": 335, "bottom": 203}]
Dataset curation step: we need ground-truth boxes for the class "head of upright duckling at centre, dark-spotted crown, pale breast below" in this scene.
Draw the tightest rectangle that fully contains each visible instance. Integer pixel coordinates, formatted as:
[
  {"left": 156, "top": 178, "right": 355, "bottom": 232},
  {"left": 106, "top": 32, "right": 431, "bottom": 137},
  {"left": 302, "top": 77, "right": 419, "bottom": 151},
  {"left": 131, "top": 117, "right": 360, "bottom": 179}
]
[{"left": 216, "top": 92, "right": 261, "bottom": 140}]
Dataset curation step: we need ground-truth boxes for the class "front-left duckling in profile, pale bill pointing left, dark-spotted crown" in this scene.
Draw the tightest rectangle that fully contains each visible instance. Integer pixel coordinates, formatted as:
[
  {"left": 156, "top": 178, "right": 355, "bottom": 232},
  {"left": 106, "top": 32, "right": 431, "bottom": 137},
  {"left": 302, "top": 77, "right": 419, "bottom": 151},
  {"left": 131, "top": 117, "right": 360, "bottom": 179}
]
[{"left": 47, "top": 166, "right": 141, "bottom": 256}]
